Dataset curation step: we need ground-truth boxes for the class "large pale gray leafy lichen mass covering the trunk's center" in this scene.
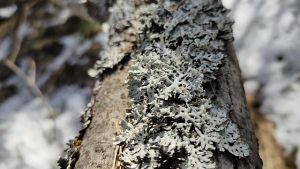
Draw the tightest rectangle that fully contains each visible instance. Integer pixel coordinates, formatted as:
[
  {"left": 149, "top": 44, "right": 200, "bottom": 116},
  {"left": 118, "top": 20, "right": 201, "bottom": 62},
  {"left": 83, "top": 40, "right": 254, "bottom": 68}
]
[{"left": 109, "top": 0, "right": 250, "bottom": 169}]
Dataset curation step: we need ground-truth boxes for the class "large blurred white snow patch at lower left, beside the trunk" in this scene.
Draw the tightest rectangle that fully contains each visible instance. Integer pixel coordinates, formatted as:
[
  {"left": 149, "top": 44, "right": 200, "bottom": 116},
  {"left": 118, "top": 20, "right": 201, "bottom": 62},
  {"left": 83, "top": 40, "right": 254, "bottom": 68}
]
[{"left": 0, "top": 86, "right": 90, "bottom": 169}]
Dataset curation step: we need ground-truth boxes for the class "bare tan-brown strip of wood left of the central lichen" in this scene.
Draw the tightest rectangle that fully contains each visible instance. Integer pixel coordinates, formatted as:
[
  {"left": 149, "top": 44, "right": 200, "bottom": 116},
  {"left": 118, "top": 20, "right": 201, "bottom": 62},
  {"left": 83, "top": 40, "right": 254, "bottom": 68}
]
[{"left": 75, "top": 65, "right": 128, "bottom": 169}]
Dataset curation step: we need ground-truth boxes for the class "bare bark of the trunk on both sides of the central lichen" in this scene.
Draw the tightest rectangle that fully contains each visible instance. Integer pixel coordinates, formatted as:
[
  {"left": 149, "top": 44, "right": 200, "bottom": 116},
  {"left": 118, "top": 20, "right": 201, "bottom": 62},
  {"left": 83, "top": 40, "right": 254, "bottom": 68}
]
[{"left": 71, "top": 44, "right": 262, "bottom": 169}]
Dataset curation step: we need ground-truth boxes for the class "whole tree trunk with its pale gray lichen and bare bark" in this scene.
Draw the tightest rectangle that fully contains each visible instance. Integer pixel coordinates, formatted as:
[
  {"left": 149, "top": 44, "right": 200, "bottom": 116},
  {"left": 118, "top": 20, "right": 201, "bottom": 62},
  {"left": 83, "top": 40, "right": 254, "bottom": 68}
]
[{"left": 58, "top": 0, "right": 262, "bottom": 169}]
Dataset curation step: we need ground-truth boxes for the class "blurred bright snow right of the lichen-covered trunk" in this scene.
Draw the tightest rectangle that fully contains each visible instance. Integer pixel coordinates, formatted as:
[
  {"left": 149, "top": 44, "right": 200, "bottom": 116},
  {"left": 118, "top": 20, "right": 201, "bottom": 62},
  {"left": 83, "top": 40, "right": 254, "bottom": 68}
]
[{"left": 223, "top": 0, "right": 300, "bottom": 168}]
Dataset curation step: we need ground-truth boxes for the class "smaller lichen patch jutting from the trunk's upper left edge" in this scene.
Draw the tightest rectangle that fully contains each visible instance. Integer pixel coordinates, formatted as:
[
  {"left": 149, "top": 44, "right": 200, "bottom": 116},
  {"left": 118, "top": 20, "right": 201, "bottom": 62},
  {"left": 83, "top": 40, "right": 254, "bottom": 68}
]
[{"left": 88, "top": 0, "right": 157, "bottom": 77}]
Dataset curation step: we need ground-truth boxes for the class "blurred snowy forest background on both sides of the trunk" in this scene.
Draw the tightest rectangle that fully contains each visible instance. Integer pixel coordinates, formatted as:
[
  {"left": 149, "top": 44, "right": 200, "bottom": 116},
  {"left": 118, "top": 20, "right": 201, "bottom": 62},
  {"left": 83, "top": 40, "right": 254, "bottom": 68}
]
[{"left": 0, "top": 0, "right": 300, "bottom": 169}]
